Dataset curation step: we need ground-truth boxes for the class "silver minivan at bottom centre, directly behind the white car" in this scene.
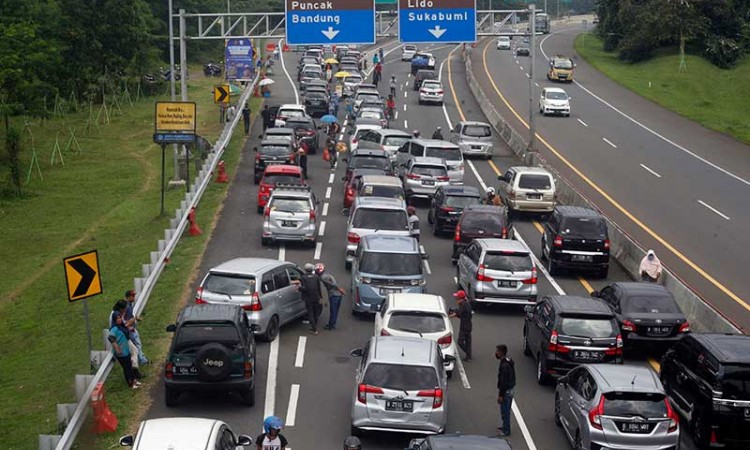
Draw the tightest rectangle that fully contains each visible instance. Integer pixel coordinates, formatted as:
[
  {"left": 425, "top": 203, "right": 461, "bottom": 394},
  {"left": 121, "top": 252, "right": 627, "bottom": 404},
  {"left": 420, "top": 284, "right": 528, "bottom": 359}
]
[{"left": 350, "top": 336, "right": 454, "bottom": 436}]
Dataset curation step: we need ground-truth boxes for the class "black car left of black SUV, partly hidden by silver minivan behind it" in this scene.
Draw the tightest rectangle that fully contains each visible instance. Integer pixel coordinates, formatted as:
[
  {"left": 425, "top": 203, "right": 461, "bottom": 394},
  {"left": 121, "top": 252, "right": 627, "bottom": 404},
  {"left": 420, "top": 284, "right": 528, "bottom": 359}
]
[{"left": 451, "top": 205, "right": 514, "bottom": 264}]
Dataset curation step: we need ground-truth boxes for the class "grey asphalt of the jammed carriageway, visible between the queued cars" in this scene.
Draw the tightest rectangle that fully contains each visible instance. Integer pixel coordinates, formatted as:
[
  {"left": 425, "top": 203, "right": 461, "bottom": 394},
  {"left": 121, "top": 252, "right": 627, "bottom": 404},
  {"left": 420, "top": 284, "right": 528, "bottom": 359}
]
[{"left": 147, "top": 43, "right": 704, "bottom": 450}]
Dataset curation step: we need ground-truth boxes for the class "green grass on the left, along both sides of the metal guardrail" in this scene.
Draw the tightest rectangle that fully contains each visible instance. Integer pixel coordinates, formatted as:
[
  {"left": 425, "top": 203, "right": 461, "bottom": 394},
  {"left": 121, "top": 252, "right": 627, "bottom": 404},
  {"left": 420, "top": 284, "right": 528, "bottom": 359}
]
[{"left": 0, "top": 67, "right": 259, "bottom": 449}]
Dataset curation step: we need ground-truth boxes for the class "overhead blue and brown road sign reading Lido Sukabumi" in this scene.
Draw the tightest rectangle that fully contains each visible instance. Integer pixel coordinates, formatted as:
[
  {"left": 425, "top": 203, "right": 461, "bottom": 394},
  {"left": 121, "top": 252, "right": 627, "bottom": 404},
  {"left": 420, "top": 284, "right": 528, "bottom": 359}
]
[{"left": 398, "top": 0, "right": 477, "bottom": 44}]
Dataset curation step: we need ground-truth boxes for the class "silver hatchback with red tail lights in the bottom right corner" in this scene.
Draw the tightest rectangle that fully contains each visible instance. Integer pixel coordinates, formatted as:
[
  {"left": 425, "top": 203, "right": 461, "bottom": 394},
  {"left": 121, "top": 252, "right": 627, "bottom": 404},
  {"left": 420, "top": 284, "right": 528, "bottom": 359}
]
[{"left": 555, "top": 364, "right": 680, "bottom": 450}]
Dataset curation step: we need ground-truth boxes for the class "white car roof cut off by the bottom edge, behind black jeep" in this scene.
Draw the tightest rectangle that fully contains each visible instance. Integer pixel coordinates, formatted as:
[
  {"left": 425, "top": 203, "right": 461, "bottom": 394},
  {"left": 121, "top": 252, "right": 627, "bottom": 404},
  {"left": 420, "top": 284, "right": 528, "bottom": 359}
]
[{"left": 120, "top": 417, "right": 255, "bottom": 450}]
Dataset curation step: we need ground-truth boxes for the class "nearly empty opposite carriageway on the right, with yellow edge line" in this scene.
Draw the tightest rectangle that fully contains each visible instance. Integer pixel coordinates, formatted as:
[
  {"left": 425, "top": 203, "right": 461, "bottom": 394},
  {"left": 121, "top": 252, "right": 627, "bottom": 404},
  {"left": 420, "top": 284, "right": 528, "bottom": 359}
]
[{"left": 472, "top": 21, "right": 750, "bottom": 331}]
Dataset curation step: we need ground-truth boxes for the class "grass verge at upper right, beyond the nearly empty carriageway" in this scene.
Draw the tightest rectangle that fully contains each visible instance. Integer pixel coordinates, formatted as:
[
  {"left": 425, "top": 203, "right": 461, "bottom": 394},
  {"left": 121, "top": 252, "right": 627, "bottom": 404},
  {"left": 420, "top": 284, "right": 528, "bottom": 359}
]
[{"left": 575, "top": 34, "right": 750, "bottom": 144}]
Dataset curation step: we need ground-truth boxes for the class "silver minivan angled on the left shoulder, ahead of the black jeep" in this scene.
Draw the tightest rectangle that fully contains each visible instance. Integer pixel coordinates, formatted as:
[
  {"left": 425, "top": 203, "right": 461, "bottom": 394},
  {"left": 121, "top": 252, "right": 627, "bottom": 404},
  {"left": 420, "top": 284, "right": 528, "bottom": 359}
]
[{"left": 195, "top": 258, "right": 307, "bottom": 341}]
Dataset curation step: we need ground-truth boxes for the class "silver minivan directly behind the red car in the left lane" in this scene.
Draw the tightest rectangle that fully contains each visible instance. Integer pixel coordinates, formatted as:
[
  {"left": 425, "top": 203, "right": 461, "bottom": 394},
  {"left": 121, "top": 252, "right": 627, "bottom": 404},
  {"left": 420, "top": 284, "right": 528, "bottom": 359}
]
[{"left": 261, "top": 188, "right": 320, "bottom": 246}]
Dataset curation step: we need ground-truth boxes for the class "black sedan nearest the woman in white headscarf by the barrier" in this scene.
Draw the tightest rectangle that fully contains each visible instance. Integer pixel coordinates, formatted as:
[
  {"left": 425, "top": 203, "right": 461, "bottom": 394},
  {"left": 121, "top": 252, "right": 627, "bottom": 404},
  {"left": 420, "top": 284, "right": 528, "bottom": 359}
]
[{"left": 591, "top": 282, "right": 690, "bottom": 350}]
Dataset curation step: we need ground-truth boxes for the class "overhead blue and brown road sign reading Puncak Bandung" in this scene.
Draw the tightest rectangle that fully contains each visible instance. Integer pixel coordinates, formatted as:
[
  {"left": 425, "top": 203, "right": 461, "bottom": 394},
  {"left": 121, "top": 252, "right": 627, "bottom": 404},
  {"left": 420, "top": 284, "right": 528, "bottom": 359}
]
[{"left": 285, "top": 0, "right": 375, "bottom": 45}]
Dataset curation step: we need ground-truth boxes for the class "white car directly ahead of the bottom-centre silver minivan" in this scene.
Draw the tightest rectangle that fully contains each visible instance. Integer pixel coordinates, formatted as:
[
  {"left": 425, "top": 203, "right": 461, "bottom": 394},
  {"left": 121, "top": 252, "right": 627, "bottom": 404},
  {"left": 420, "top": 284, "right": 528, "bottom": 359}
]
[{"left": 375, "top": 293, "right": 459, "bottom": 378}]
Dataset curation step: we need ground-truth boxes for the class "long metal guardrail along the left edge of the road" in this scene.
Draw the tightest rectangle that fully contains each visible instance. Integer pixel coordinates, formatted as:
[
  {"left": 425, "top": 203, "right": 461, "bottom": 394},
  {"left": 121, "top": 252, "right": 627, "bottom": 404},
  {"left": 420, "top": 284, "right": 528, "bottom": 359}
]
[{"left": 39, "top": 77, "right": 258, "bottom": 450}]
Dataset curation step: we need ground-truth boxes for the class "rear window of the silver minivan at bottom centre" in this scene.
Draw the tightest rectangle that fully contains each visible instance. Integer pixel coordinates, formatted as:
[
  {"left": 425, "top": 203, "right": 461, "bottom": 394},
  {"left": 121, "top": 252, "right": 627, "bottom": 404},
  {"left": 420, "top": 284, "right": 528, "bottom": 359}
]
[{"left": 362, "top": 363, "right": 438, "bottom": 391}]
